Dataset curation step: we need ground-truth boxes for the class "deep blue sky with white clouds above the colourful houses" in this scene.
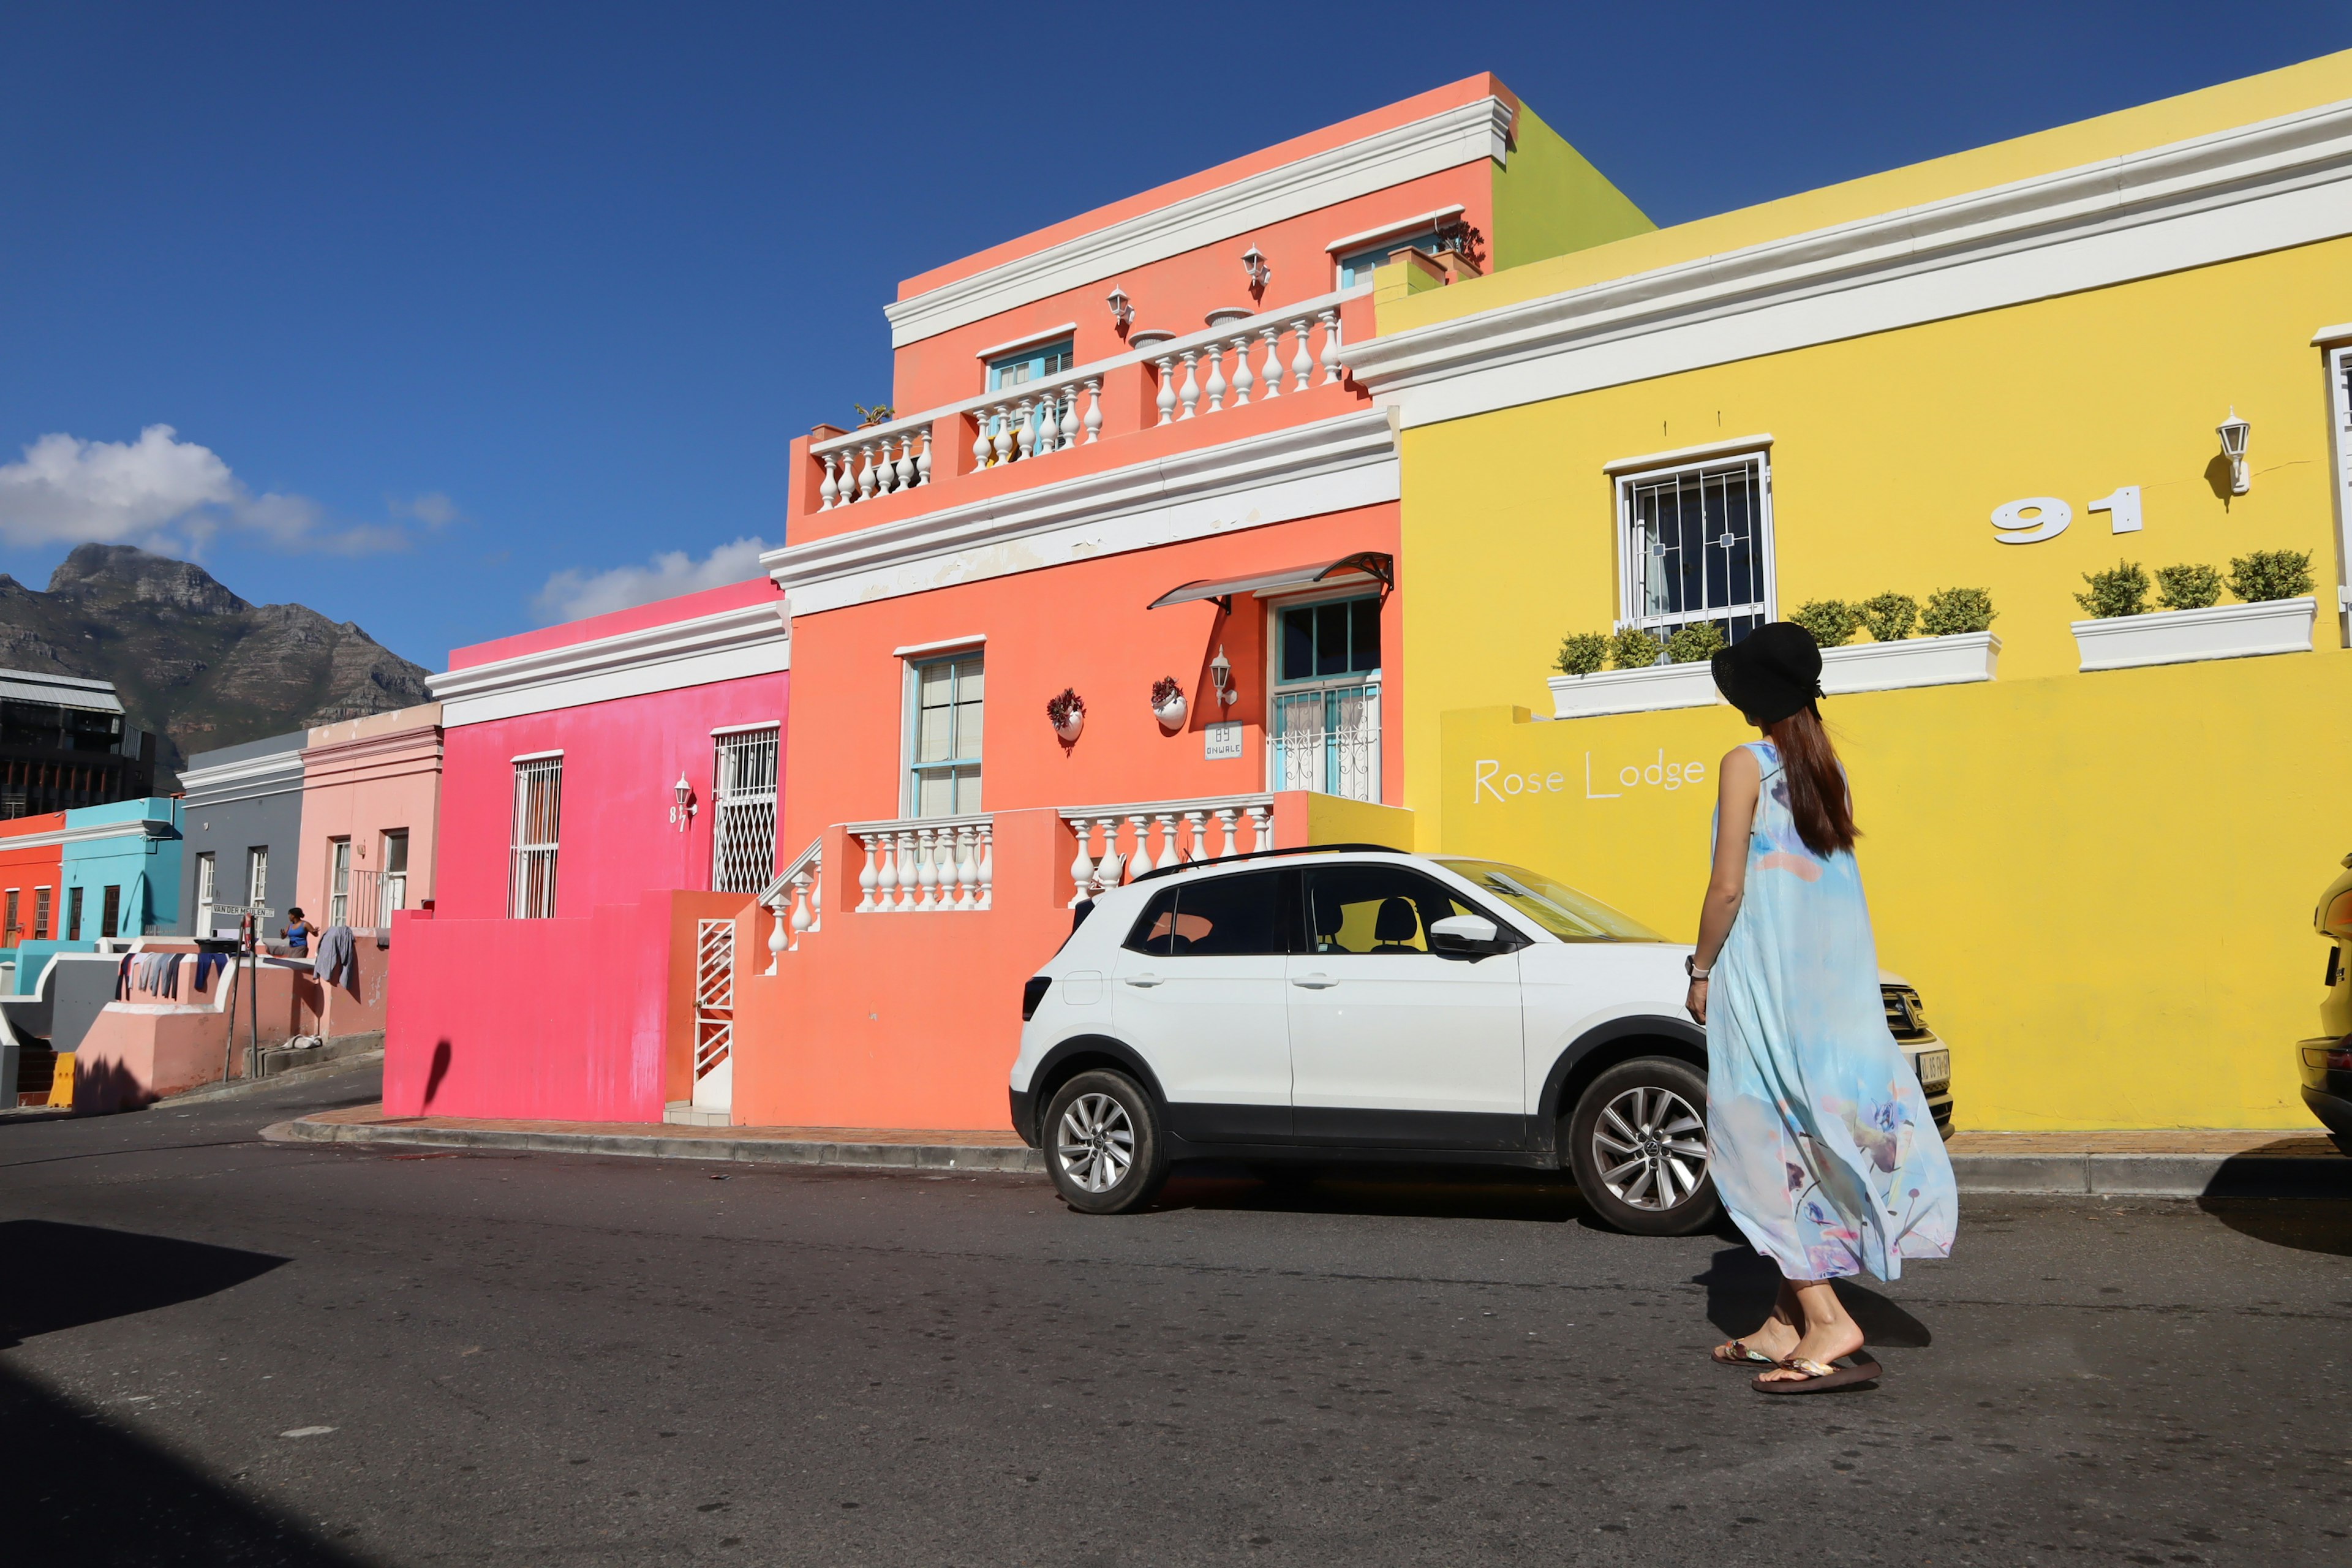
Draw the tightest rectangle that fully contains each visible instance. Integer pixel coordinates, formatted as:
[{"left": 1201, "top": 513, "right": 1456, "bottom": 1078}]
[{"left": 0, "top": 0, "right": 2352, "bottom": 668}]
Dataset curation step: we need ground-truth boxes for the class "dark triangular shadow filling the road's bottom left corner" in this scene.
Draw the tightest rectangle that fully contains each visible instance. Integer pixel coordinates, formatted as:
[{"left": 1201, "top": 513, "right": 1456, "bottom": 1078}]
[{"left": 0, "top": 1363, "right": 362, "bottom": 1568}]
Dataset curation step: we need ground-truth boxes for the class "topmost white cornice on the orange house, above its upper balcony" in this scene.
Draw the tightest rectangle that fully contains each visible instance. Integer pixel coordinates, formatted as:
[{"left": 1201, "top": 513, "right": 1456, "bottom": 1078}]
[{"left": 882, "top": 96, "right": 1512, "bottom": 348}]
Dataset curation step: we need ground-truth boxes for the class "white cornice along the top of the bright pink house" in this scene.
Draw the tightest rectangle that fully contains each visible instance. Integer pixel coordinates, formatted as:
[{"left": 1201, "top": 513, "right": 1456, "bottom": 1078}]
[{"left": 440, "top": 600, "right": 793, "bottom": 733}]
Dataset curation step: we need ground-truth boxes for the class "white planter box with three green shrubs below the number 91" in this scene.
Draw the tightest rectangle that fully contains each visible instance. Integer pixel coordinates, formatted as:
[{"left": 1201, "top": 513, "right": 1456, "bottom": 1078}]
[{"left": 2072, "top": 550, "right": 2319, "bottom": 670}]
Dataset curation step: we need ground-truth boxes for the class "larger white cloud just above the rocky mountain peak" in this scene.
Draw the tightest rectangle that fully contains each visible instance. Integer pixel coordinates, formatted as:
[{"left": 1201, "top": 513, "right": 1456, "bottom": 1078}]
[{"left": 0, "top": 426, "right": 413, "bottom": 555}]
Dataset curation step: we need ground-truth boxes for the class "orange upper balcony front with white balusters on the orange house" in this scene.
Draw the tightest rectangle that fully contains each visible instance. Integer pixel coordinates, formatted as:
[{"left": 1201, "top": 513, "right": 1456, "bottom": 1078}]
[{"left": 793, "top": 284, "right": 1371, "bottom": 541}]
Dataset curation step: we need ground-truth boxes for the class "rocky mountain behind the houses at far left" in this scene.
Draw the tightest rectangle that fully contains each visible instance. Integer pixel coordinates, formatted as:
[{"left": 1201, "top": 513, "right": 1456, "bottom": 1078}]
[{"left": 0, "top": 545, "right": 431, "bottom": 790}]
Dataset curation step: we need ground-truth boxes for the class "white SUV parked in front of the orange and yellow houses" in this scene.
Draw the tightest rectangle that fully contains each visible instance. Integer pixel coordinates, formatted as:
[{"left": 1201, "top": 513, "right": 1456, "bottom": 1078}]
[{"left": 1011, "top": 844, "right": 1950, "bottom": 1234}]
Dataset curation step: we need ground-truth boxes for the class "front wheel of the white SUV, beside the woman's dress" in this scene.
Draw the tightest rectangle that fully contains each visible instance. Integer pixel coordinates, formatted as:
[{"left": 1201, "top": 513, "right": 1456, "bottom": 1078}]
[{"left": 1569, "top": 1055, "right": 1724, "bottom": 1237}]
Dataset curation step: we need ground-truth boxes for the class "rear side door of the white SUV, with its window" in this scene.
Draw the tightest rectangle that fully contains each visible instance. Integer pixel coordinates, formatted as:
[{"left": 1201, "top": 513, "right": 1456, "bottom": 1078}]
[{"left": 1110, "top": 870, "right": 1291, "bottom": 1142}]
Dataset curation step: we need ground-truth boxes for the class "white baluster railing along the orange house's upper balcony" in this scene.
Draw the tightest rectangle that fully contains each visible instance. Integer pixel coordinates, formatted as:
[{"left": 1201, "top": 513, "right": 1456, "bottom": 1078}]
[{"left": 809, "top": 289, "right": 1362, "bottom": 513}]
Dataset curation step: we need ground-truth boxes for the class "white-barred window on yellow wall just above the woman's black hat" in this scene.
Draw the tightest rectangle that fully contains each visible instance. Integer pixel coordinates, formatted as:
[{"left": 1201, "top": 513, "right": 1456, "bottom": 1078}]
[{"left": 1618, "top": 454, "right": 1771, "bottom": 642}]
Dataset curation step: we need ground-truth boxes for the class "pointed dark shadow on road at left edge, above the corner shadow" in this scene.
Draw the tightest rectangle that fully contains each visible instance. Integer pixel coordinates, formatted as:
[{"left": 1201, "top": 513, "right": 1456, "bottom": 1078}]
[{"left": 0, "top": 1220, "right": 287, "bottom": 1349}]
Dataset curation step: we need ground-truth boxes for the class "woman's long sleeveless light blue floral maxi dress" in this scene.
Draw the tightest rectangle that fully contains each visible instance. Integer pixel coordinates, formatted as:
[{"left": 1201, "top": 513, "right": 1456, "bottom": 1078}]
[{"left": 1708, "top": 741, "right": 1959, "bottom": 1279}]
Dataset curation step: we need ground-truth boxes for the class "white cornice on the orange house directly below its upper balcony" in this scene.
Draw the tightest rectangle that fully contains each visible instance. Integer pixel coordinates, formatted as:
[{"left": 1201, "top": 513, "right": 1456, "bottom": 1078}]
[{"left": 760, "top": 409, "right": 1397, "bottom": 616}]
